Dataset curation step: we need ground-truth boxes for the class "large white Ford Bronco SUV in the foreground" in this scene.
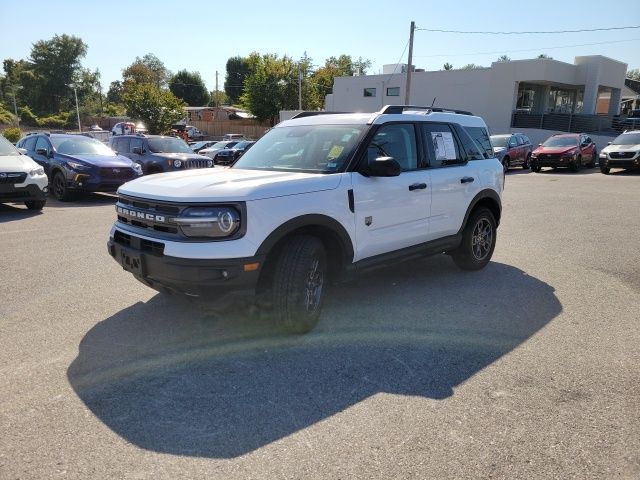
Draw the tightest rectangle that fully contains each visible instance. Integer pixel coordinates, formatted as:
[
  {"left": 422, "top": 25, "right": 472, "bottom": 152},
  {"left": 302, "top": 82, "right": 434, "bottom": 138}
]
[{"left": 108, "top": 106, "right": 504, "bottom": 333}]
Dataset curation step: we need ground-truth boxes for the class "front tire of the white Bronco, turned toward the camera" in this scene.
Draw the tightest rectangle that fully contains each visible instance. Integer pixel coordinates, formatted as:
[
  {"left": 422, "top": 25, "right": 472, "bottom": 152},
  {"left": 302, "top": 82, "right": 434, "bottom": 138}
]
[{"left": 271, "top": 235, "right": 327, "bottom": 334}]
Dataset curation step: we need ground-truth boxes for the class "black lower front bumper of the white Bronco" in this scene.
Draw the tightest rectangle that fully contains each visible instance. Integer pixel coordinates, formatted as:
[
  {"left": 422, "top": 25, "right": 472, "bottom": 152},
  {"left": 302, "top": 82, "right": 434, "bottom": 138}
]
[{"left": 107, "top": 231, "right": 265, "bottom": 300}]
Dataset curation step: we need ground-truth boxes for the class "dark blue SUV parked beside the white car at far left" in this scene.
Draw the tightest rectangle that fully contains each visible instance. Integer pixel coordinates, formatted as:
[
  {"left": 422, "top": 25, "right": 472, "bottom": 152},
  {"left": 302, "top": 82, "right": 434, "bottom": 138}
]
[{"left": 16, "top": 133, "right": 142, "bottom": 201}]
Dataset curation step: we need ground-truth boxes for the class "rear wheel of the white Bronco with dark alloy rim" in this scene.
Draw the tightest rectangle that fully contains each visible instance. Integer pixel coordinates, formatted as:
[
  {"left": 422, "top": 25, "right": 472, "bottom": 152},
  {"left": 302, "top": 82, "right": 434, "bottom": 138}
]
[{"left": 451, "top": 207, "right": 496, "bottom": 270}]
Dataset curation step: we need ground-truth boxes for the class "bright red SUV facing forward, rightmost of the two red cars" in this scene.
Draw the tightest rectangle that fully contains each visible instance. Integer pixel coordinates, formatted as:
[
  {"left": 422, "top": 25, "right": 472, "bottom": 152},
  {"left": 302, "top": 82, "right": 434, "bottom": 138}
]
[{"left": 531, "top": 133, "right": 598, "bottom": 172}]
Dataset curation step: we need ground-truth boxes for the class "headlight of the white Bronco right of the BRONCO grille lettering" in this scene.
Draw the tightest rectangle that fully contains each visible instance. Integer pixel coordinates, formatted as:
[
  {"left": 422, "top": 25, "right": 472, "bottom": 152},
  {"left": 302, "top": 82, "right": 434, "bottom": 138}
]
[{"left": 175, "top": 207, "right": 240, "bottom": 238}]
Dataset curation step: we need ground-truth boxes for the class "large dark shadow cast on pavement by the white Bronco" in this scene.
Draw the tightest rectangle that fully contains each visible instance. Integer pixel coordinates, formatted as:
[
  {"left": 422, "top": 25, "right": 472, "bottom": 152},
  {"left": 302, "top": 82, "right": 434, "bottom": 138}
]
[{"left": 67, "top": 255, "right": 562, "bottom": 458}]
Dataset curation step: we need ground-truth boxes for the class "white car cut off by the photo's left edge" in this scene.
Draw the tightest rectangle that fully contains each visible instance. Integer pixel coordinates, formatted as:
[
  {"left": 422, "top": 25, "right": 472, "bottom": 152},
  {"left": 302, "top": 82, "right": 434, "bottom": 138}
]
[{"left": 0, "top": 135, "right": 49, "bottom": 210}]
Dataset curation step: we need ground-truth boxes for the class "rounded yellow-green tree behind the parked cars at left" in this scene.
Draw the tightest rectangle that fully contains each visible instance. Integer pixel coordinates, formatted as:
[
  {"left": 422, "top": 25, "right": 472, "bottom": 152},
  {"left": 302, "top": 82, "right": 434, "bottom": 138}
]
[{"left": 123, "top": 83, "right": 185, "bottom": 134}]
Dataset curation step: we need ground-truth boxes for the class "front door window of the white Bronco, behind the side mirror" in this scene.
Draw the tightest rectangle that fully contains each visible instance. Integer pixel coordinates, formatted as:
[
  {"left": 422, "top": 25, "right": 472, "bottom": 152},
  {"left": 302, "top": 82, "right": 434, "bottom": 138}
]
[{"left": 367, "top": 123, "right": 418, "bottom": 172}]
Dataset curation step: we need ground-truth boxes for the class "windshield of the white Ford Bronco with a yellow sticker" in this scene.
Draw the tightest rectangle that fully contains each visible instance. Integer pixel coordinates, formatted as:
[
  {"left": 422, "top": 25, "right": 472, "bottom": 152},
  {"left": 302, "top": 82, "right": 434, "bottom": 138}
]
[{"left": 233, "top": 125, "right": 365, "bottom": 173}]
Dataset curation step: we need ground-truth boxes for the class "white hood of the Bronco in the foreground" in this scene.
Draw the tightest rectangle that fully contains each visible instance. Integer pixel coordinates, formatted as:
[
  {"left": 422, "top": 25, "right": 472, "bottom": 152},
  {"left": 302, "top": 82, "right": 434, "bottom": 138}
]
[{"left": 118, "top": 167, "right": 342, "bottom": 202}]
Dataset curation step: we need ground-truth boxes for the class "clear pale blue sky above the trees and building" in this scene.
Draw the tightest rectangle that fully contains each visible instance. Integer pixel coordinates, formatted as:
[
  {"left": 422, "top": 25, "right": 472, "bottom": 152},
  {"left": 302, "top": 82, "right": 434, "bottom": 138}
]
[{"left": 0, "top": 0, "right": 640, "bottom": 91}]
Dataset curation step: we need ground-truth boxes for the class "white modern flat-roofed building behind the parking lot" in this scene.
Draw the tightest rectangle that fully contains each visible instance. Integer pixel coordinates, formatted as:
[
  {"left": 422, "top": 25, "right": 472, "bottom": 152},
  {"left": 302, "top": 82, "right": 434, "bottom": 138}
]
[{"left": 325, "top": 55, "right": 627, "bottom": 132}]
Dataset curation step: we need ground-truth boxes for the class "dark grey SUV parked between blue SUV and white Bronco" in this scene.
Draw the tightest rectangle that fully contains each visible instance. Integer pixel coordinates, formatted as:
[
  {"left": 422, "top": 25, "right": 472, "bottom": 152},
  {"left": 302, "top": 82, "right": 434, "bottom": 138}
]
[{"left": 109, "top": 134, "right": 214, "bottom": 174}]
